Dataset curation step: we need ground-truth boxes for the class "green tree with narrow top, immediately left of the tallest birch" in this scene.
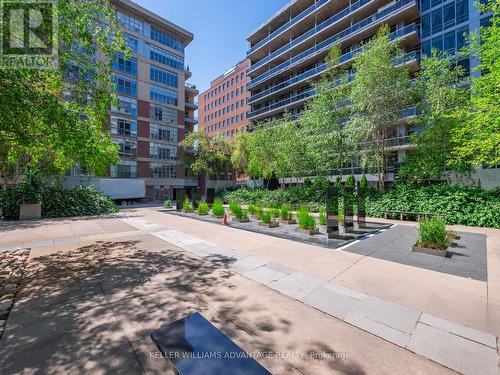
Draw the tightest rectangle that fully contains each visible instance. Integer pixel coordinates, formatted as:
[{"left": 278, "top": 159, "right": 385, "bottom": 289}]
[{"left": 299, "top": 45, "right": 352, "bottom": 175}]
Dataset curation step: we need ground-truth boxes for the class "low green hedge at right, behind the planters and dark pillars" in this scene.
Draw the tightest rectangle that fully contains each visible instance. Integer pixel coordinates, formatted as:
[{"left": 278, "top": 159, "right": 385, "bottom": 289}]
[{"left": 222, "top": 183, "right": 500, "bottom": 228}]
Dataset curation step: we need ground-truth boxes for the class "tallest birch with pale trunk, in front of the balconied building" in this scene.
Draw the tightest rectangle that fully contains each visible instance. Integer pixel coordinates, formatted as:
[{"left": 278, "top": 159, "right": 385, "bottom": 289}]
[{"left": 348, "top": 25, "right": 412, "bottom": 187}]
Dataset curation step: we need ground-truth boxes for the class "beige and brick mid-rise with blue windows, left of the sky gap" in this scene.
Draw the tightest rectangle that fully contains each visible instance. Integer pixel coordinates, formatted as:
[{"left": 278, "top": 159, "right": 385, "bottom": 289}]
[{"left": 110, "top": 0, "right": 198, "bottom": 200}]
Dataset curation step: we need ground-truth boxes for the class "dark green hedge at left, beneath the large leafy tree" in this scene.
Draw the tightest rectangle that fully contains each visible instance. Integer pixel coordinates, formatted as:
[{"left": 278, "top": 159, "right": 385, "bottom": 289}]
[{"left": 0, "top": 184, "right": 118, "bottom": 220}]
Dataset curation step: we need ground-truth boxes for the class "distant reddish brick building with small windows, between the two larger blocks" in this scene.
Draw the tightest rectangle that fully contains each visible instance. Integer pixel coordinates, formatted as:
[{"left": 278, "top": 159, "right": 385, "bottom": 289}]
[{"left": 198, "top": 60, "right": 249, "bottom": 141}]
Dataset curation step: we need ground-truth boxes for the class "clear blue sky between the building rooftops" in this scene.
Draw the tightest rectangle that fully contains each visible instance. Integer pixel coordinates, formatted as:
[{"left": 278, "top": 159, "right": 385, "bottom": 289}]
[{"left": 133, "top": 0, "right": 289, "bottom": 92}]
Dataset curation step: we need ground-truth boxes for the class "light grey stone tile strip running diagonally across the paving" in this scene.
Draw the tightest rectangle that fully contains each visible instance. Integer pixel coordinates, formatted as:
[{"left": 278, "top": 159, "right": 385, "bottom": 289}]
[{"left": 121, "top": 218, "right": 499, "bottom": 375}]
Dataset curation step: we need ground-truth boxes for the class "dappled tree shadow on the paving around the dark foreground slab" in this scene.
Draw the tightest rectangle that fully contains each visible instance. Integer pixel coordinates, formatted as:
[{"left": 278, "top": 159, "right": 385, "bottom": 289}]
[{"left": 0, "top": 236, "right": 363, "bottom": 374}]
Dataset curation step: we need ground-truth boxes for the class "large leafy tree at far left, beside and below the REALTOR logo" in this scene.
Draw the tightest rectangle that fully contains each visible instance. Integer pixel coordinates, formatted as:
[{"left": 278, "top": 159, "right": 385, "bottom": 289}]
[{"left": 0, "top": 0, "right": 125, "bottom": 183}]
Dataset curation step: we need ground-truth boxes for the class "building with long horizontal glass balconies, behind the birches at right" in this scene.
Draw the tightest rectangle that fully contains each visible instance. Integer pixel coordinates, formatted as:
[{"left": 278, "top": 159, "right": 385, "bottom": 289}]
[{"left": 247, "top": 0, "right": 488, "bottom": 181}]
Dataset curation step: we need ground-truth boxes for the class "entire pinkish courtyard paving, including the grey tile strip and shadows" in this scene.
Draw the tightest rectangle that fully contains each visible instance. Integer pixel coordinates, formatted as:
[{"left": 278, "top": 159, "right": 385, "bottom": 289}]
[{"left": 0, "top": 208, "right": 500, "bottom": 374}]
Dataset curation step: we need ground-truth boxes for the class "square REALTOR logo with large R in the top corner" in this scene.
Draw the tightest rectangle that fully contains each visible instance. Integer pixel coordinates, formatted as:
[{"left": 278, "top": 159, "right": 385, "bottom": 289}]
[{"left": 0, "top": 0, "right": 57, "bottom": 69}]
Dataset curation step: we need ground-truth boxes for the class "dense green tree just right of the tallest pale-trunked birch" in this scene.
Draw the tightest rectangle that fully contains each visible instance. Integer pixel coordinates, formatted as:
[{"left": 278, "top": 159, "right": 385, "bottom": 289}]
[{"left": 400, "top": 50, "right": 469, "bottom": 182}]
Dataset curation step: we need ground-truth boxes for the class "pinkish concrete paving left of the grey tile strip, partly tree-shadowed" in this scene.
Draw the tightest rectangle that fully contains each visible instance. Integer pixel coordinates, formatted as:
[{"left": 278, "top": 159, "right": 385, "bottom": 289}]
[{"left": 0, "top": 216, "right": 458, "bottom": 375}]
